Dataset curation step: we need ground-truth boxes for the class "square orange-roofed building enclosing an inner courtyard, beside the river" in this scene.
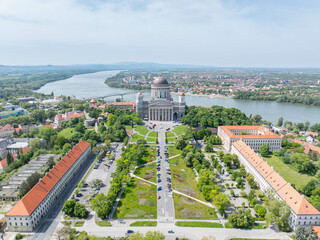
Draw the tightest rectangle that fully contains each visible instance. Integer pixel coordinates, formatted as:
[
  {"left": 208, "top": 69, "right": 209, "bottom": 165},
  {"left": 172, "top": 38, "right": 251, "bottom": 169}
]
[{"left": 218, "top": 126, "right": 282, "bottom": 152}]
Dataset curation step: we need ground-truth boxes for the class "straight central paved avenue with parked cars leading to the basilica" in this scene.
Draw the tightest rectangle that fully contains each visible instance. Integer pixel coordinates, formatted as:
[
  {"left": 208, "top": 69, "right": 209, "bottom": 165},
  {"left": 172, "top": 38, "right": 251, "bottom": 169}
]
[{"left": 156, "top": 124, "right": 174, "bottom": 223}]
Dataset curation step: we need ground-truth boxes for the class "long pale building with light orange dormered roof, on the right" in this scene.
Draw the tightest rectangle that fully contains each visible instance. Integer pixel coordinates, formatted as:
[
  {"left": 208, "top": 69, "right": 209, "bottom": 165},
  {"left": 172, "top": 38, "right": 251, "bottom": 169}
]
[{"left": 231, "top": 140, "right": 320, "bottom": 230}]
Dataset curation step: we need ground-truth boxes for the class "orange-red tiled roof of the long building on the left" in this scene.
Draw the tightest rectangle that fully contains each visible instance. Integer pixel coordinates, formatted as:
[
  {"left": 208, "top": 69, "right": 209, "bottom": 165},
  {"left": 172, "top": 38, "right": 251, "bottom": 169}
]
[{"left": 6, "top": 141, "right": 90, "bottom": 216}]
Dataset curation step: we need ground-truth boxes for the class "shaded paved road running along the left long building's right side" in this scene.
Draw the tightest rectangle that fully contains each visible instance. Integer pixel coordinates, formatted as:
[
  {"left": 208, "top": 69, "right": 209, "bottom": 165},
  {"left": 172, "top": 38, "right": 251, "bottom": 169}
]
[{"left": 32, "top": 155, "right": 96, "bottom": 240}]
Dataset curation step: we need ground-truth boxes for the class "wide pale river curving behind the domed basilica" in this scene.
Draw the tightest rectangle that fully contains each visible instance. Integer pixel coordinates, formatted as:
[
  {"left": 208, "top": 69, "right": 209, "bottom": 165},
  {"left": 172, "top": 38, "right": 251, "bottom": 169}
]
[{"left": 37, "top": 71, "right": 320, "bottom": 124}]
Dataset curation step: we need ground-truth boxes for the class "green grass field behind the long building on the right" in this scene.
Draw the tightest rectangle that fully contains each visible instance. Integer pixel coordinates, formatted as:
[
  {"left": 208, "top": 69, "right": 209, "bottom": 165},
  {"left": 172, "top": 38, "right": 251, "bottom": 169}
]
[{"left": 263, "top": 155, "right": 315, "bottom": 189}]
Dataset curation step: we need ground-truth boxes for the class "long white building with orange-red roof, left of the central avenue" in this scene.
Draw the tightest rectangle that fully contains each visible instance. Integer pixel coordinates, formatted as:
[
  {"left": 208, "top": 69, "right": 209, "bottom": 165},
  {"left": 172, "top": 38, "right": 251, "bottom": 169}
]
[{"left": 5, "top": 141, "right": 91, "bottom": 232}]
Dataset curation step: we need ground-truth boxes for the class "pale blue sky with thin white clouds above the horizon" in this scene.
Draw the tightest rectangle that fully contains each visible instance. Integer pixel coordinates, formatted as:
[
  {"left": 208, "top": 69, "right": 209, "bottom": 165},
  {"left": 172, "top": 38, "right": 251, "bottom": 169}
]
[{"left": 0, "top": 0, "right": 320, "bottom": 68}]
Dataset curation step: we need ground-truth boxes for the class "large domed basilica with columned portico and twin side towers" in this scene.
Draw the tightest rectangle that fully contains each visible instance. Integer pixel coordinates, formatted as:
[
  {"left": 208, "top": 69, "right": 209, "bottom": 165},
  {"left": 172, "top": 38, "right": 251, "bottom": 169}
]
[{"left": 136, "top": 75, "right": 186, "bottom": 121}]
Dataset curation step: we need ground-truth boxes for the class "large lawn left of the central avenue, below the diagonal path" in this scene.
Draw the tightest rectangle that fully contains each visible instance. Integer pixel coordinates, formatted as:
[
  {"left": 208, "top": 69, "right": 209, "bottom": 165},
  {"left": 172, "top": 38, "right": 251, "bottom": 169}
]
[{"left": 114, "top": 178, "right": 157, "bottom": 218}]
